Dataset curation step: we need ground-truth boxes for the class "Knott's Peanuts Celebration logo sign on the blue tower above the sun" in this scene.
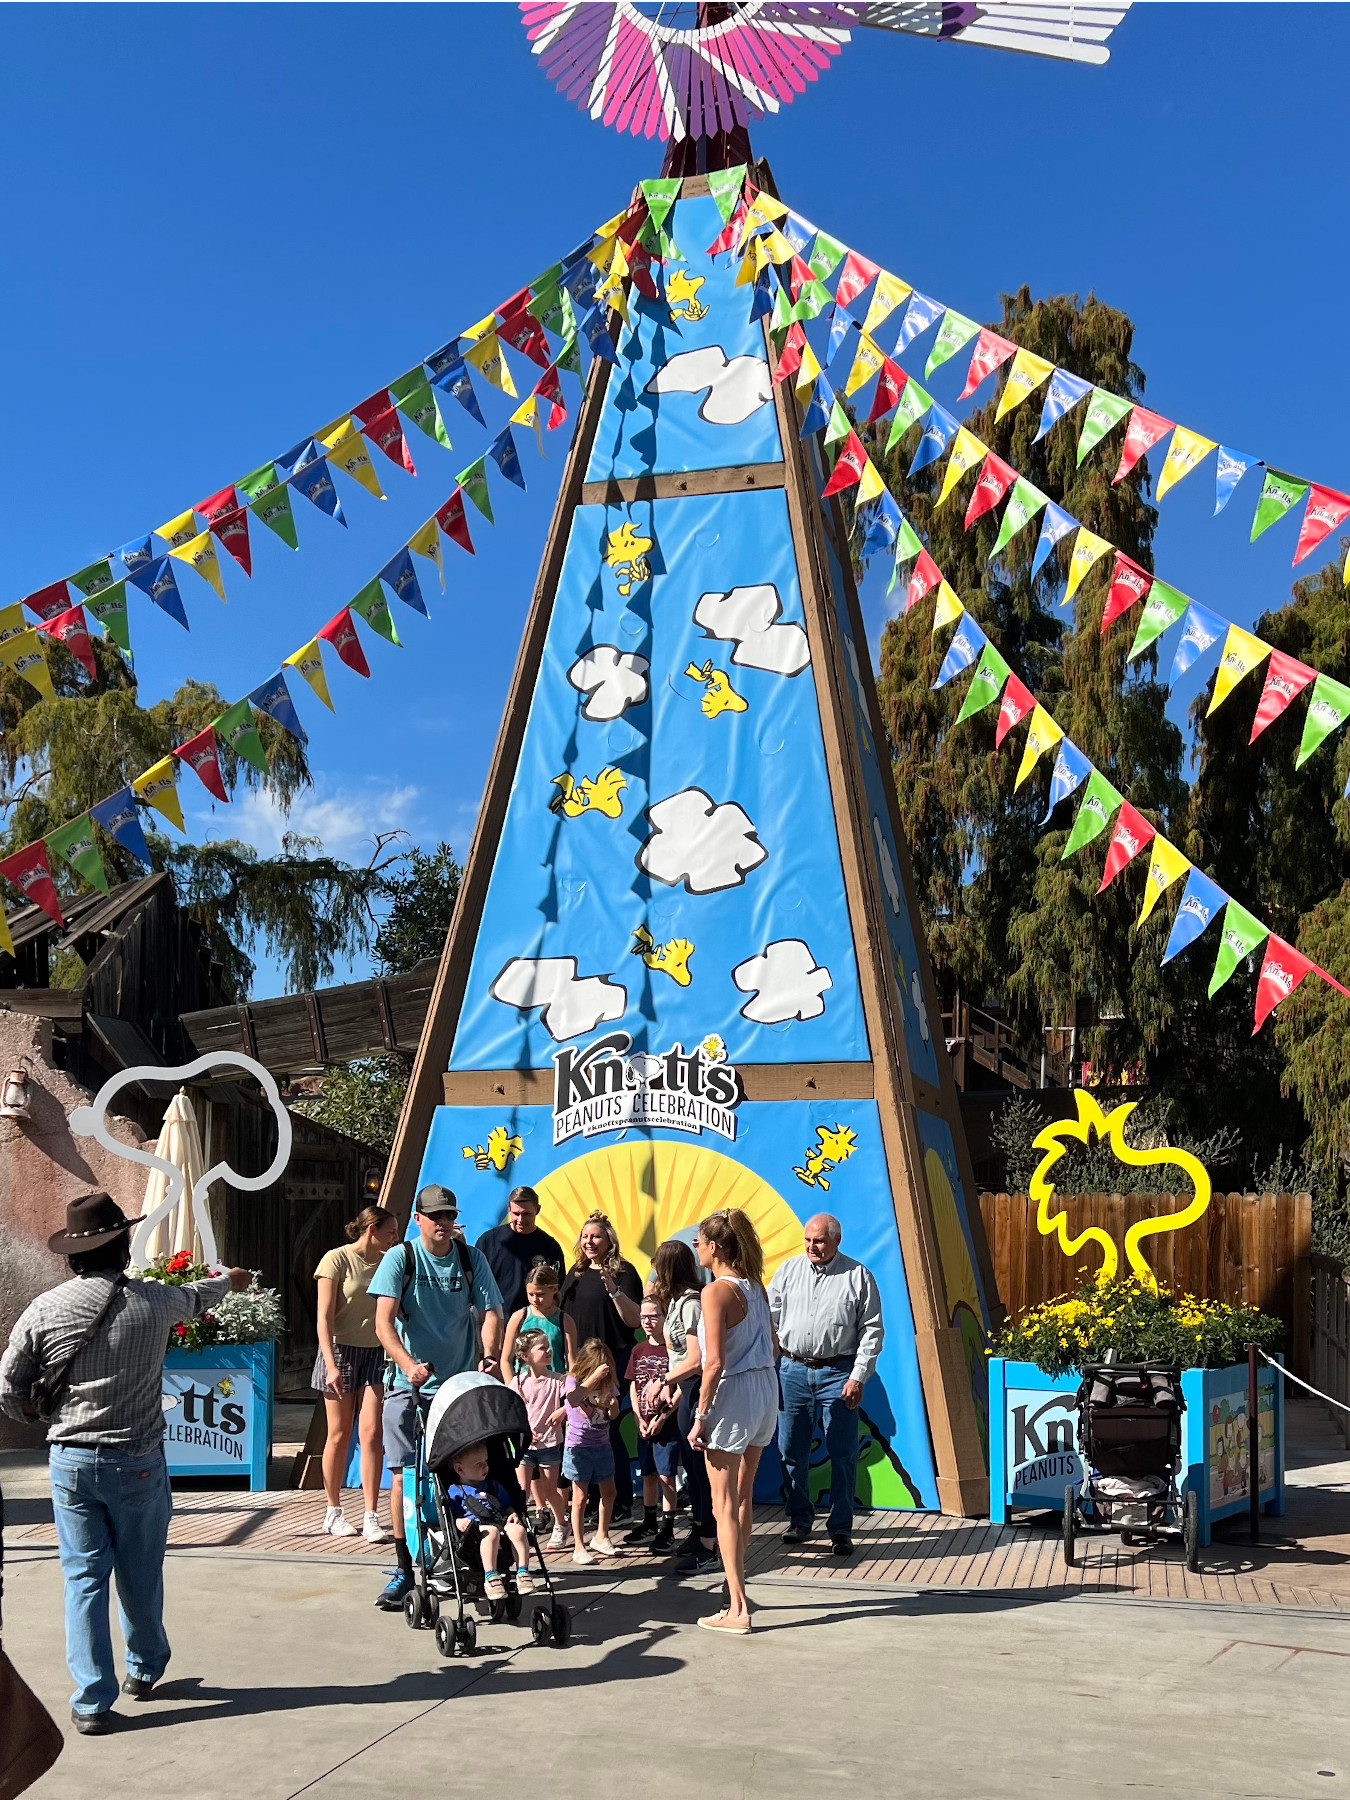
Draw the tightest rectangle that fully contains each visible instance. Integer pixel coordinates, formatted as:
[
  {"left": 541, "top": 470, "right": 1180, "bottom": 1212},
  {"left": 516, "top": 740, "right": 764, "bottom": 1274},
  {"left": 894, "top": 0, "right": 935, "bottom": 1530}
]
[{"left": 553, "top": 1031, "right": 745, "bottom": 1145}]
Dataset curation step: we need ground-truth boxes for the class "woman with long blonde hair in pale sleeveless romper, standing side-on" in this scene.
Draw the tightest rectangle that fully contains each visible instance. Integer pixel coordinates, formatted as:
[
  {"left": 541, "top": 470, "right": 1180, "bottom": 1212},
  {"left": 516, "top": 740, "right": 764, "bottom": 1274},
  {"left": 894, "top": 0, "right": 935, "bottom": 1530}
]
[{"left": 689, "top": 1206, "right": 778, "bottom": 1638}]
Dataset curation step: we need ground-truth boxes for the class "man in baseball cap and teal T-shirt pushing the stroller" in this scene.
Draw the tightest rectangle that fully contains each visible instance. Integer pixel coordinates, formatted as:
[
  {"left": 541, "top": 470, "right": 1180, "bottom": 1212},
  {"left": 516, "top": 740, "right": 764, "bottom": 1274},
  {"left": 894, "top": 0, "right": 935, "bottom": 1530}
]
[{"left": 367, "top": 1183, "right": 504, "bottom": 1613}]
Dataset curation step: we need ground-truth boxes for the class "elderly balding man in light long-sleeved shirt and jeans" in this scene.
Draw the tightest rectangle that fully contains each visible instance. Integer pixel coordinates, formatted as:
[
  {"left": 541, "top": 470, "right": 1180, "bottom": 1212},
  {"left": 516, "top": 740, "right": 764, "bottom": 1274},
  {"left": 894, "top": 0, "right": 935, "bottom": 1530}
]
[{"left": 769, "top": 1213, "right": 884, "bottom": 1557}]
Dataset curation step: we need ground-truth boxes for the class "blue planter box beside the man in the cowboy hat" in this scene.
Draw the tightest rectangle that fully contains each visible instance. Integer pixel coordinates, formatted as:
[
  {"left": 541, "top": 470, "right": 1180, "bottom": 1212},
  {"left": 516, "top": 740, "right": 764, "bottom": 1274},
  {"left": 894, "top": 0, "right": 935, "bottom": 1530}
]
[{"left": 164, "top": 1343, "right": 277, "bottom": 1494}]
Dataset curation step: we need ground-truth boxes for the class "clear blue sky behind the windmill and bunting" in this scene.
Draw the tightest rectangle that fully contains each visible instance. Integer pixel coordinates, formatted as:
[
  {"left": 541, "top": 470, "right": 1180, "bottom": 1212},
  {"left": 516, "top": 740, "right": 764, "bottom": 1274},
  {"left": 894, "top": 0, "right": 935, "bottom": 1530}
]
[{"left": 0, "top": 4, "right": 1350, "bottom": 992}]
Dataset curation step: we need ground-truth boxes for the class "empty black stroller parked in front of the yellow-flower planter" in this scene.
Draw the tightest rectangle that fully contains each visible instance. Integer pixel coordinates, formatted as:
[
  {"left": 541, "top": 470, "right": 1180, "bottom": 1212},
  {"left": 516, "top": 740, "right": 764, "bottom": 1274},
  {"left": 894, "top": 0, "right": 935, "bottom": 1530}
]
[{"left": 1064, "top": 1352, "right": 1201, "bottom": 1570}]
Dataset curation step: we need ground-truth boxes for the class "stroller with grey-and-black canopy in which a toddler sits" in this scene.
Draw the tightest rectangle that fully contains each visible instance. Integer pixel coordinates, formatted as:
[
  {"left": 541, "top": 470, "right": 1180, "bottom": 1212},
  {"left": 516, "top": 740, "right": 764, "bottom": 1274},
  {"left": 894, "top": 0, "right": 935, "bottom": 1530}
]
[{"left": 403, "top": 1373, "right": 572, "bottom": 1656}]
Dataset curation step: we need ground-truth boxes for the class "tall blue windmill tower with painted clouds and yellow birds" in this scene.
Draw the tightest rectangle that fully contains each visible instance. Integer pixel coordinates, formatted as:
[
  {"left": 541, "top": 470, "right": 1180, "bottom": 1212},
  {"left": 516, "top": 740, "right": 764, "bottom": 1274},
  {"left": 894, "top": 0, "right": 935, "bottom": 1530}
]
[{"left": 385, "top": 5, "right": 1130, "bottom": 1514}]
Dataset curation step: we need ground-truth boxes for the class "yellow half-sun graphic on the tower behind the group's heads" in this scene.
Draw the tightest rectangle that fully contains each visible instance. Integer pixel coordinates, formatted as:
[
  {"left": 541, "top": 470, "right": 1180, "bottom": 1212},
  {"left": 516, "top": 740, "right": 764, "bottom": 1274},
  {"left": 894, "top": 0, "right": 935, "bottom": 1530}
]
[{"left": 535, "top": 1139, "right": 801, "bottom": 1280}]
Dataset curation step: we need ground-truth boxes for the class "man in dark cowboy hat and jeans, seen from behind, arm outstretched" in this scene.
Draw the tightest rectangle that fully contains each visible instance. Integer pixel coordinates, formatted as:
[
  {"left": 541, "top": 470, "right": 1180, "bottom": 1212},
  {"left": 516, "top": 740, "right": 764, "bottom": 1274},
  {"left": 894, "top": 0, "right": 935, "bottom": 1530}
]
[{"left": 0, "top": 1193, "right": 252, "bottom": 1737}]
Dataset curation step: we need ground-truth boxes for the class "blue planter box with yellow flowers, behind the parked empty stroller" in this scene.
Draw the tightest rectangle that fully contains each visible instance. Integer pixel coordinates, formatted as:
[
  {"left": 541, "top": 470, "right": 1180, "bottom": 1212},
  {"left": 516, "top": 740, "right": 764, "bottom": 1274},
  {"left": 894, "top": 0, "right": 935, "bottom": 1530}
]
[{"left": 988, "top": 1355, "right": 1285, "bottom": 1544}]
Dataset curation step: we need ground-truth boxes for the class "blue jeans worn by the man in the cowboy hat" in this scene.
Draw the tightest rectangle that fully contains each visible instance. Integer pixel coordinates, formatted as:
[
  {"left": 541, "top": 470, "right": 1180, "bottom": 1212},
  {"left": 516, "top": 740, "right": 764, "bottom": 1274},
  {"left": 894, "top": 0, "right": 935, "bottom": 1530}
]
[{"left": 50, "top": 1444, "right": 173, "bottom": 1712}]
